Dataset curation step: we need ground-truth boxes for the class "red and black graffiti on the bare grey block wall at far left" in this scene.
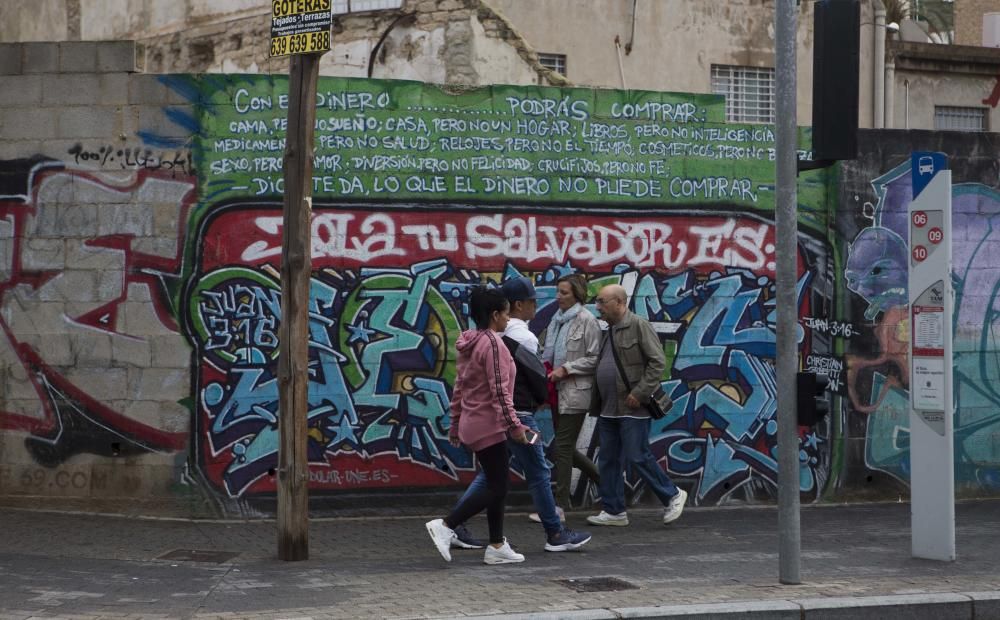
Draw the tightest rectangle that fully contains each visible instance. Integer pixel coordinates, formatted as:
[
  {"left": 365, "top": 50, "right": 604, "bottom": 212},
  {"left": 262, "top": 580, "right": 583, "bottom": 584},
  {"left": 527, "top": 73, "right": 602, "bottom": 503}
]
[{"left": 0, "top": 159, "right": 195, "bottom": 508}]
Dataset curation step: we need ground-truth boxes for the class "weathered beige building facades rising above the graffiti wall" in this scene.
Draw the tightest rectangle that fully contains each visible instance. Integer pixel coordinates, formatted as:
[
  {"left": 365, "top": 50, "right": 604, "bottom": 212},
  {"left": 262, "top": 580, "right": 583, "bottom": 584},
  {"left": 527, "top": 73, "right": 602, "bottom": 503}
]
[{"left": 0, "top": 0, "right": 1000, "bottom": 130}]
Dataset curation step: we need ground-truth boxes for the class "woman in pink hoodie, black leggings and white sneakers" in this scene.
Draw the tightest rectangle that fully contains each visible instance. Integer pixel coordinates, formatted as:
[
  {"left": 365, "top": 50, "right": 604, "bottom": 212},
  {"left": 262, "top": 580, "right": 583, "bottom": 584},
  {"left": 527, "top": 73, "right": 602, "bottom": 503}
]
[{"left": 427, "top": 287, "right": 528, "bottom": 564}]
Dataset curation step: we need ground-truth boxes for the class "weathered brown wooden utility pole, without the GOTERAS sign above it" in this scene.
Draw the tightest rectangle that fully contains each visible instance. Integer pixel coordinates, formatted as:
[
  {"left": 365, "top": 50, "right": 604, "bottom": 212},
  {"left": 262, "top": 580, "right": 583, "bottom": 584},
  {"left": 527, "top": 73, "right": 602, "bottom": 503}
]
[{"left": 278, "top": 54, "right": 322, "bottom": 561}]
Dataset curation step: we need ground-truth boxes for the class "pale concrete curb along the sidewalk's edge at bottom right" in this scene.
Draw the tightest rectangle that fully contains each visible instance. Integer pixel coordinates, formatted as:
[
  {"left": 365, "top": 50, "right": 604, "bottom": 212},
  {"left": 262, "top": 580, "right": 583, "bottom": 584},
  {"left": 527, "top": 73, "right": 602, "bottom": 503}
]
[{"left": 444, "top": 591, "right": 1000, "bottom": 620}]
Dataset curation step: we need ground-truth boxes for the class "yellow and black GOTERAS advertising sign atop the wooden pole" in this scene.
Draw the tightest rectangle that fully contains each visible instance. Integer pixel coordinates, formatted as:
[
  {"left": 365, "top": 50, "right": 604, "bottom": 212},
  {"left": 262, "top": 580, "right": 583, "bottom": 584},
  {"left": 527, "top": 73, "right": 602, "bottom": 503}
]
[{"left": 270, "top": 0, "right": 333, "bottom": 57}]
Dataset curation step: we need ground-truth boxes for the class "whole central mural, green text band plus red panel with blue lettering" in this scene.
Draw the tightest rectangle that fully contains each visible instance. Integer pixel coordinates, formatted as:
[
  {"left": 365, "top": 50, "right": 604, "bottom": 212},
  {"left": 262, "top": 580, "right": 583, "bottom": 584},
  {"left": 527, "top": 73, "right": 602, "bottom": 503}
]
[{"left": 171, "top": 78, "right": 832, "bottom": 504}]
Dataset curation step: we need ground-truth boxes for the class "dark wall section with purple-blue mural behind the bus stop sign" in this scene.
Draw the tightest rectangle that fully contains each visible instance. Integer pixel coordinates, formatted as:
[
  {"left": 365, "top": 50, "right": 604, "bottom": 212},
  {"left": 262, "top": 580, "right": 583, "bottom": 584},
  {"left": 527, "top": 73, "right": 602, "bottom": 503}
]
[{"left": 837, "top": 132, "right": 1000, "bottom": 495}]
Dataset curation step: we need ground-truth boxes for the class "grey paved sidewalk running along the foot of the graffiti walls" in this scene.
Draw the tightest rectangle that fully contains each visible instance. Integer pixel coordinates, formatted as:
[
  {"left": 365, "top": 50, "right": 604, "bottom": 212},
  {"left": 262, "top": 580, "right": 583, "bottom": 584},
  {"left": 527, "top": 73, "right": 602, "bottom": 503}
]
[{"left": 0, "top": 500, "right": 1000, "bottom": 620}]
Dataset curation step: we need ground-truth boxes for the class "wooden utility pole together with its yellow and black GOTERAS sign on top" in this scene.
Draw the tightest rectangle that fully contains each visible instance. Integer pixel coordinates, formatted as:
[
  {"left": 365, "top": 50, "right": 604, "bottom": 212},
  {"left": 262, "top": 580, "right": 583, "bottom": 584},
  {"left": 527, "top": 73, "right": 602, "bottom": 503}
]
[{"left": 270, "top": 0, "right": 402, "bottom": 561}]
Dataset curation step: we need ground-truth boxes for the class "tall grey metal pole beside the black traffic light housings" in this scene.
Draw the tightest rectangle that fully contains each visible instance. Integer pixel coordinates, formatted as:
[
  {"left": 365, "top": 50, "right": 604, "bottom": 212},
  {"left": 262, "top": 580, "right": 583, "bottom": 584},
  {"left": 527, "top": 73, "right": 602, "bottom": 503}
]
[{"left": 774, "top": 0, "right": 801, "bottom": 584}]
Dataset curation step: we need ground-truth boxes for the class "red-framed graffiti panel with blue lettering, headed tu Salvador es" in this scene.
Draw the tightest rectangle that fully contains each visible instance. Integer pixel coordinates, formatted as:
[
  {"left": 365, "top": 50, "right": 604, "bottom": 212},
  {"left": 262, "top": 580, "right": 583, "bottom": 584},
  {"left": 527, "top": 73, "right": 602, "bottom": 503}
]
[{"left": 191, "top": 203, "right": 824, "bottom": 504}]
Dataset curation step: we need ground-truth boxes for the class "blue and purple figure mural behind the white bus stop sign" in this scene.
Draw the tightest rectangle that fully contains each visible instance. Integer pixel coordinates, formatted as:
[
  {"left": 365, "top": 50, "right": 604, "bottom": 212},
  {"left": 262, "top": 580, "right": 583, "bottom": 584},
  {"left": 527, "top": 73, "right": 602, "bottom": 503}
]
[{"left": 844, "top": 163, "right": 1000, "bottom": 489}]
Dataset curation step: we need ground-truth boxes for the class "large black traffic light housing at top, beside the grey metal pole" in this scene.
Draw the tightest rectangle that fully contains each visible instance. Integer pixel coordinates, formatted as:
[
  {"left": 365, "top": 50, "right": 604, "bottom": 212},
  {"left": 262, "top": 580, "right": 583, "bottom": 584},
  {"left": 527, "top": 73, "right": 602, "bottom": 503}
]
[{"left": 800, "top": 0, "right": 861, "bottom": 170}]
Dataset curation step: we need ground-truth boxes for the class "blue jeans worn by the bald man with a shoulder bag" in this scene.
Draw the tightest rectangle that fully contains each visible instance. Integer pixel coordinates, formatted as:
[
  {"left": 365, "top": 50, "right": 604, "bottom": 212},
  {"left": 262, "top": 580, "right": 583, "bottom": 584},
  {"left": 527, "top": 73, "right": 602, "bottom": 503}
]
[{"left": 597, "top": 417, "right": 677, "bottom": 515}]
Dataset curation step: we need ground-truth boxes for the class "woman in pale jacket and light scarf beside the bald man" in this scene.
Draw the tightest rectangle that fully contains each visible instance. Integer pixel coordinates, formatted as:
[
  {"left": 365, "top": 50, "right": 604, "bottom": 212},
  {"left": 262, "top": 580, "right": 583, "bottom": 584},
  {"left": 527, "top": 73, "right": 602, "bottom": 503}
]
[{"left": 542, "top": 274, "right": 601, "bottom": 509}]
